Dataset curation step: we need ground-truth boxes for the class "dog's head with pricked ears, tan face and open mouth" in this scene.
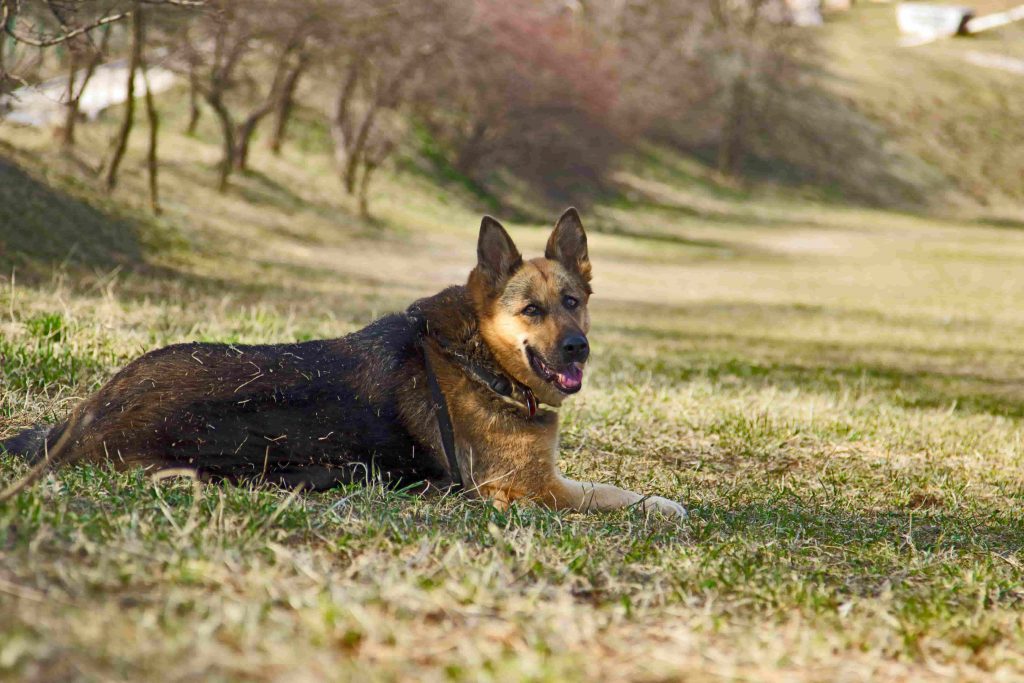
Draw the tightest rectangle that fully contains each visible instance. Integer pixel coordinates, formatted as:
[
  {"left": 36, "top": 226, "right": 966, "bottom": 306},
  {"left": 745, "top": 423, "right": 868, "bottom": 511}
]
[{"left": 468, "top": 209, "right": 591, "bottom": 405}]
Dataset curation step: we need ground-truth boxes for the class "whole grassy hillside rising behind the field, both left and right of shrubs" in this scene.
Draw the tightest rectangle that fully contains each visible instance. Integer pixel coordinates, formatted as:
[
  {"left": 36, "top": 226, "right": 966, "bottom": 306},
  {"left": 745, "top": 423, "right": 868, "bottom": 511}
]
[{"left": 0, "top": 0, "right": 1024, "bottom": 280}]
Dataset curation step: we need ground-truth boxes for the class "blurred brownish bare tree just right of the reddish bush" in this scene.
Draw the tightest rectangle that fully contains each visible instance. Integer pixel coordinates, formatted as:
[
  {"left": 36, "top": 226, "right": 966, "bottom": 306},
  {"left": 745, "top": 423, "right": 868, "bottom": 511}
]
[{"left": 586, "top": 0, "right": 813, "bottom": 176}]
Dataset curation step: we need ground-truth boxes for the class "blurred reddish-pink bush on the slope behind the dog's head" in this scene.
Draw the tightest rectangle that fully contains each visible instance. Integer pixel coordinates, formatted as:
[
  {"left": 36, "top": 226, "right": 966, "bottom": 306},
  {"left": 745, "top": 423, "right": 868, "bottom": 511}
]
[{"left": 418, "top": 0, "right": 628, "bottom": 202}]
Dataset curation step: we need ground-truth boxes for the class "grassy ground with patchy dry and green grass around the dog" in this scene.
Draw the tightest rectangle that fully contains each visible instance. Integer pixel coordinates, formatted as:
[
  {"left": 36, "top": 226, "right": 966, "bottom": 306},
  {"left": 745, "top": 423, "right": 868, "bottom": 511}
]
[{"left": 0, "top": 9, "right": 1024, "bottom": 681}]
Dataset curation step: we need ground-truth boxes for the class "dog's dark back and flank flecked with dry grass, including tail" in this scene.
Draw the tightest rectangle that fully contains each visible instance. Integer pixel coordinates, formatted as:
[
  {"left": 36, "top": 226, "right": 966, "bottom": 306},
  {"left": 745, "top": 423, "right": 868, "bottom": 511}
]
[{"left": 2, "top": 288, "right": 479, "bottom": 489}]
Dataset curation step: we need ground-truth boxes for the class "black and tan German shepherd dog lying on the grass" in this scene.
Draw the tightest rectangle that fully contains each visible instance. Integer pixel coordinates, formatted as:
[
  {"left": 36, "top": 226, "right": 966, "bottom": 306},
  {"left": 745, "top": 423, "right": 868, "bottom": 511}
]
[{"left": 3, "top": 209, "right": 686, "bottom": 517}]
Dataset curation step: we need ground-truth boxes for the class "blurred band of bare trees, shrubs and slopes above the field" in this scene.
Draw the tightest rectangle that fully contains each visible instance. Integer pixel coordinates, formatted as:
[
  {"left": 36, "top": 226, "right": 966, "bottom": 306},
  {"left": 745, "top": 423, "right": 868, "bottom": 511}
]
[{"left": 0, "top": 0, "right": 1024, "bottom": 232}]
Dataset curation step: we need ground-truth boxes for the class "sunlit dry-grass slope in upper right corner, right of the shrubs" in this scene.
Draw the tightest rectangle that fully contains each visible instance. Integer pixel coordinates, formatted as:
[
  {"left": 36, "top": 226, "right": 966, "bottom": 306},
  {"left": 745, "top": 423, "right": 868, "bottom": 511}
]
[{"left": 821, "top": 0, "right": 1024, "bottom": 211}]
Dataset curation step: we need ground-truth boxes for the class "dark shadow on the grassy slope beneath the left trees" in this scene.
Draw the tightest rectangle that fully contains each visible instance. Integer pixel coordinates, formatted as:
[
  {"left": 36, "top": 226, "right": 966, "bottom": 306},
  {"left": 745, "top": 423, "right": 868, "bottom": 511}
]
[{"left": 0, "top": 148, "right": 388, "bottom": 303}]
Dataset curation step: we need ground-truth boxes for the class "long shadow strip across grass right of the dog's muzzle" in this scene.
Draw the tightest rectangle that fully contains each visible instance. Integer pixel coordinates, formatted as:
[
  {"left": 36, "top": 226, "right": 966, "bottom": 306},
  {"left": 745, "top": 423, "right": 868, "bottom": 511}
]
[{"left": 605, "top": 304, "right": 1024, "bottom": 419}]
